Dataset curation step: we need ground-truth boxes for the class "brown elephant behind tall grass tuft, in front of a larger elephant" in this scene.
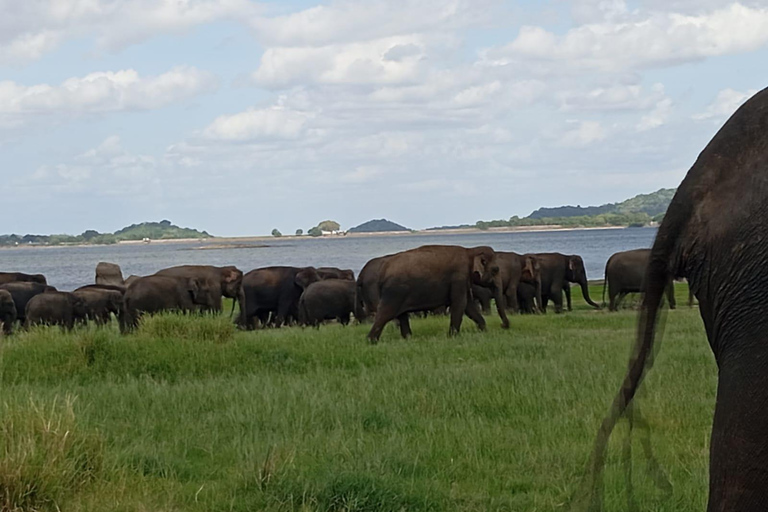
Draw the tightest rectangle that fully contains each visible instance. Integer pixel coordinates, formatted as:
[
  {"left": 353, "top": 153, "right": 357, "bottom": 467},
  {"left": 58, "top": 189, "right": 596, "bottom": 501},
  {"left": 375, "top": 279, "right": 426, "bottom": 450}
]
[{"left": 119, "top": 275, "right": 216, "bottom": 333}]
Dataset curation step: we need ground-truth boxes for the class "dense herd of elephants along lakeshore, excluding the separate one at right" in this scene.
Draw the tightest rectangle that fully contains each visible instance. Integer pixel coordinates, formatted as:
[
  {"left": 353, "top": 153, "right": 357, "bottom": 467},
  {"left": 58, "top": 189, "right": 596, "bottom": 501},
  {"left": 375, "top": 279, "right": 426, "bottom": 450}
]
[{"left": 0, "top": 245, "right": 599, "bottom": 343}]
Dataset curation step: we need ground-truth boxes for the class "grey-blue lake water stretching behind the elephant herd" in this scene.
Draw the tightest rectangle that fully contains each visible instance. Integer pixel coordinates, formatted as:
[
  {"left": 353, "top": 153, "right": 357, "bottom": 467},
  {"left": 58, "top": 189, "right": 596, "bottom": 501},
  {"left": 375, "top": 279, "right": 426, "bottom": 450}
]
[{"left": 0, "top": 228, "right": 656, "bottom": 290}]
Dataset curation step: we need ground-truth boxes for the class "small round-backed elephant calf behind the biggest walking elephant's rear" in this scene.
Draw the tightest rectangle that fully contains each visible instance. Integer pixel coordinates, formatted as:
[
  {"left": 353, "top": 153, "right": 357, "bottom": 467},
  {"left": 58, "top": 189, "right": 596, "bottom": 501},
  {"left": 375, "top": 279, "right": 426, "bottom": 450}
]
[{"left": 299, "top": 279, "right": 361, "bottom": 327}]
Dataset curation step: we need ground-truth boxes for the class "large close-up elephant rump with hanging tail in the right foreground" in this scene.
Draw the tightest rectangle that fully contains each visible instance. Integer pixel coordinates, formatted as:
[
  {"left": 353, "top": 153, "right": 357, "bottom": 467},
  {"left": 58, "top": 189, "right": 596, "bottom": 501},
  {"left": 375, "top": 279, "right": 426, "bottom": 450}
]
[{"left": 589, "top": 89, "right": 768, "bottom": 512}]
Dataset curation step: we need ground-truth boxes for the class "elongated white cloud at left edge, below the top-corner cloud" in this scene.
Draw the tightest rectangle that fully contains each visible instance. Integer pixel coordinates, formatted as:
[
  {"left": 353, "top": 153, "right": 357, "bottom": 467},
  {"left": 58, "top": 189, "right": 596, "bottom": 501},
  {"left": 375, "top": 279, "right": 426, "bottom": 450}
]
[{"left": 0, "top": 66, "right": 217, "bottom": 124}]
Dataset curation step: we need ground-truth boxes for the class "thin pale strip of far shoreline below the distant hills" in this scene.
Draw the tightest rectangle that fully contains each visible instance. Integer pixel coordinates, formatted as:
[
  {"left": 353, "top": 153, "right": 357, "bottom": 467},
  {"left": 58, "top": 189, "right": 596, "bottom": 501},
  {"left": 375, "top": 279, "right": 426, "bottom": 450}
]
[{"left": 0, "top": 226, "right": 634, "bottom": 250}]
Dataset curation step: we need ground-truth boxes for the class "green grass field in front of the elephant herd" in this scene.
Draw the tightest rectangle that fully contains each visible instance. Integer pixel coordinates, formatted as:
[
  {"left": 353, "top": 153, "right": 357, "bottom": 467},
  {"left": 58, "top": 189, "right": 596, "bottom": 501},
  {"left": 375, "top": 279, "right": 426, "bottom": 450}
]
[{"left": 0, "top": 287, "right": 716, "bottom": 512}]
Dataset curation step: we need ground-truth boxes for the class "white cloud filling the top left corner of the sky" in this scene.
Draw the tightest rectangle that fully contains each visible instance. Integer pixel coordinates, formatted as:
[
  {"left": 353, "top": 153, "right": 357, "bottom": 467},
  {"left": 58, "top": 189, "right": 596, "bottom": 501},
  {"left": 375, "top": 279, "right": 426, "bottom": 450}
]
[{"left": 0, "top": 0, "right": 257, "bottom": 64}]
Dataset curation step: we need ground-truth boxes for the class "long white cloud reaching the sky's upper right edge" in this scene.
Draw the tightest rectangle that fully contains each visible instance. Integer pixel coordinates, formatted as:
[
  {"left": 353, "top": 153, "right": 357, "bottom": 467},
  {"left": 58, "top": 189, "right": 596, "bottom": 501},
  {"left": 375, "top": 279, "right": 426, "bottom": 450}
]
[{"left": 482, "top": 3, "right": 768, "bottom": 73}]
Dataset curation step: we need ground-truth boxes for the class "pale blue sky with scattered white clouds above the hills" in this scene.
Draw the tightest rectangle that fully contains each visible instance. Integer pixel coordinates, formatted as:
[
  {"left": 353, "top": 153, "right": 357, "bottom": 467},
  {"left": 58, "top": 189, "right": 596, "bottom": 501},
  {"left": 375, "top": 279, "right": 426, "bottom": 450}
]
[{"left": 0, "top": 0, "right": 768, "bottom": 235}]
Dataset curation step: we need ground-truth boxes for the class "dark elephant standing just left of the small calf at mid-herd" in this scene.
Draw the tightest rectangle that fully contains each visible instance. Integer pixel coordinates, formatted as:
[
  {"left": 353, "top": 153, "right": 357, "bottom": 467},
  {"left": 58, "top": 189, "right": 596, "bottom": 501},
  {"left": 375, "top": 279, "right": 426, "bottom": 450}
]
[{"left": 241, "top": 267, "right": 321, "bottom": 329}]
